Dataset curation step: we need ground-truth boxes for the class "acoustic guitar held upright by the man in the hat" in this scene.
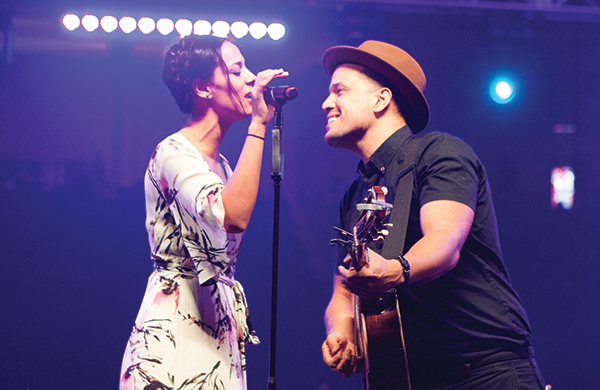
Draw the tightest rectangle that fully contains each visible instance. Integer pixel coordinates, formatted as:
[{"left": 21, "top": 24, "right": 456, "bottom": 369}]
[{"left": 330, "top": 186, "right": 411, "bottom": 390}]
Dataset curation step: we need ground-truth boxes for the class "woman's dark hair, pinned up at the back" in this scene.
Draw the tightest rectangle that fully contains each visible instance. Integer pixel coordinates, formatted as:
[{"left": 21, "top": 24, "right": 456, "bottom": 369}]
[{"left": 162, "top": 35, "right": 225, "bottom": 114}]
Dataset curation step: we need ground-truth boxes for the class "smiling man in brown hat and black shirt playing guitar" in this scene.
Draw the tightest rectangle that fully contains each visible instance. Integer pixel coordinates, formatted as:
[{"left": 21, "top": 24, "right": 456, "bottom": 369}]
[{"left": 323, "top": 41, "right": 543, "bottom": 390}]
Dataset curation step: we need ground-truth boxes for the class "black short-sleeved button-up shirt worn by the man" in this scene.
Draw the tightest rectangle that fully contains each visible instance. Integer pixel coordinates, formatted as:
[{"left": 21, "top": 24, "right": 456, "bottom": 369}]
[{"left": 337, "top": 127, "right": 530, "bottom": 378}]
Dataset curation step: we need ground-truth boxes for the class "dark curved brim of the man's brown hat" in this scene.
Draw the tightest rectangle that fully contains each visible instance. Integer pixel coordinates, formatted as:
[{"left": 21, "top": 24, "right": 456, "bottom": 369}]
[{"left": 323, "top": 46, "right": 429, "bottom": 133}]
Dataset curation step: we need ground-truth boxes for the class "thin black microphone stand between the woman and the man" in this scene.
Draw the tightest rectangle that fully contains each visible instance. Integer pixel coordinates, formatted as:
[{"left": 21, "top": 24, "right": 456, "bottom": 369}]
[{"left": 268, "top": 99, "right": 286, "bottom": 390}]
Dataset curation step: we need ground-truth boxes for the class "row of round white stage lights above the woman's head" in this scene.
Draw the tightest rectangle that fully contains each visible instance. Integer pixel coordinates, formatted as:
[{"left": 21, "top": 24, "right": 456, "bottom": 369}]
[{"left": 62, "top": 13, "right": 286, "bottom": 41}]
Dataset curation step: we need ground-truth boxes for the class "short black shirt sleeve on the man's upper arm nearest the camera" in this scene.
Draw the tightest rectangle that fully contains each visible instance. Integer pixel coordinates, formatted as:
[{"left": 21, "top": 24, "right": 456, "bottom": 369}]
[{"left": 416, "top": 133, "right": 481, "bottom": 210}]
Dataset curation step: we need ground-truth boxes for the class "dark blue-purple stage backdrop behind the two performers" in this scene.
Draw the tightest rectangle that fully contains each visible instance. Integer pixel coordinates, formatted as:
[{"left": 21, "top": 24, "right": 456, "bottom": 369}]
[{"left": 0, "top": 0, "right": 600, "bottom": 390}]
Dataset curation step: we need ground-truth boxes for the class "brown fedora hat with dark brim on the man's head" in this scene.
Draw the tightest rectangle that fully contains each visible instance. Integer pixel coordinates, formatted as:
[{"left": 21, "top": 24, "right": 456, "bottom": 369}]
[{"left": 323, "top": 41, "right": 429, "bottom": 133}]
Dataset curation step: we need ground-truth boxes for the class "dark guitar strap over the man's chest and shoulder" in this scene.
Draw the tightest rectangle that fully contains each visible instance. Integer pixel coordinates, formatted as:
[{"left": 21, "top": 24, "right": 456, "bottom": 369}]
[{"left": 381, "top": 136, "right": 421, "bottom": 259}]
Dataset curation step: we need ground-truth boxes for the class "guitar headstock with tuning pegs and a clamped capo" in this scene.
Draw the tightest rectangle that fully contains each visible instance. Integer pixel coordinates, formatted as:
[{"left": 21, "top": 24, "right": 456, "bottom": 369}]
[{"left": 330, "top": 186, "right": 393, "bottom": 270}]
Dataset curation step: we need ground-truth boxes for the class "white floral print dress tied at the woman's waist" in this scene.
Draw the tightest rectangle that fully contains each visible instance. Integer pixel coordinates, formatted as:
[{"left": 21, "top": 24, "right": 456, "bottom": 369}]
[{"left": 120, "top": 133, "right": 258, "bottom": 390}]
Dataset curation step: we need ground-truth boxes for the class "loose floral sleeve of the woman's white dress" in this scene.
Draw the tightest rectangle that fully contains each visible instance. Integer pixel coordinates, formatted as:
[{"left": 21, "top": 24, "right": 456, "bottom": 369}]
[{"left": 154, "top": 138, "right": 232, "bottom": 283}]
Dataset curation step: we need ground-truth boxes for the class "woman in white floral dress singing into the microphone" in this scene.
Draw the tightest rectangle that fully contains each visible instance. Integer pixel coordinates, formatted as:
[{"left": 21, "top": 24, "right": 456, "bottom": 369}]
[{"left": 120, "top": 36, "right": 288, "bottom": 390}]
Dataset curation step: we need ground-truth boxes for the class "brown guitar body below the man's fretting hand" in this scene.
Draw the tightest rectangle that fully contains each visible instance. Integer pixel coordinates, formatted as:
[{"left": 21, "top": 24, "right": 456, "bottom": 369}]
[{"left": 355, "top": 291, "right": 411, "bottom": 390}]
